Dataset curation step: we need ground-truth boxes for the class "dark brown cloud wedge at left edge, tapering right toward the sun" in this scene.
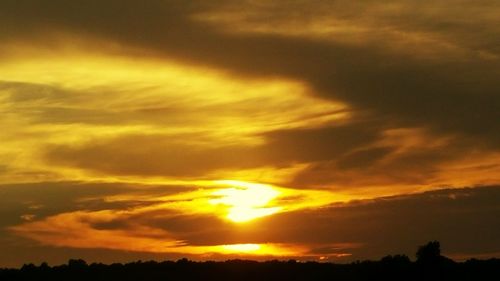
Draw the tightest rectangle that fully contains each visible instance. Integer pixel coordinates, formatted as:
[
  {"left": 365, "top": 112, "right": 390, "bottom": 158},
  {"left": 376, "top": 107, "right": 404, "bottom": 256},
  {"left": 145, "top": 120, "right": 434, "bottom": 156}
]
[{"left": 0, "top": 182, "right": 190, "bottom": 227}]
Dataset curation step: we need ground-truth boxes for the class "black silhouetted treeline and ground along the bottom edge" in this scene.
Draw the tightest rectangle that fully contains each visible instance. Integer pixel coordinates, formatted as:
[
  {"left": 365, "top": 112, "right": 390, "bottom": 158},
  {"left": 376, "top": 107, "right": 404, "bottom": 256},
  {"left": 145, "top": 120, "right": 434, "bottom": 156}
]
[{"left": 0, "top": 241, "right": 500, "bottom": 281}]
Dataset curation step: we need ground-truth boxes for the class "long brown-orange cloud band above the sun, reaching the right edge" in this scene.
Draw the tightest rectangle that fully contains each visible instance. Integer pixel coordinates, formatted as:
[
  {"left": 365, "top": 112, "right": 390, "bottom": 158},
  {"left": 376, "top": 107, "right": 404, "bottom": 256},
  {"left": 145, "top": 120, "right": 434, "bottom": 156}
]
[{"left": 41, "top": 122, "right": 500, "bottom": 191}]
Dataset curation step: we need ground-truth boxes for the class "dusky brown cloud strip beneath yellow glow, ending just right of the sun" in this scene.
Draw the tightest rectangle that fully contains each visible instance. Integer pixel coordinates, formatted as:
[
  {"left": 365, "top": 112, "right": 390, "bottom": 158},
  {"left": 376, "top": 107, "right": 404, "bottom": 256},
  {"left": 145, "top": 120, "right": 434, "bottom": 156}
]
[{"left": 47, "top": 123, "right": 378, "bottom": 177}]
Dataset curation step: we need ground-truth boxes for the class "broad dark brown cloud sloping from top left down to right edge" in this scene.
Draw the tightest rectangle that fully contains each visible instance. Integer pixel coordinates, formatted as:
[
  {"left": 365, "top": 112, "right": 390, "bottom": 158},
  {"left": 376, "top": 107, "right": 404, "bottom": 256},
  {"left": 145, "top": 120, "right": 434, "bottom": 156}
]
[{"left": 2, "top": 1, "right": 500, "bottom": 148}]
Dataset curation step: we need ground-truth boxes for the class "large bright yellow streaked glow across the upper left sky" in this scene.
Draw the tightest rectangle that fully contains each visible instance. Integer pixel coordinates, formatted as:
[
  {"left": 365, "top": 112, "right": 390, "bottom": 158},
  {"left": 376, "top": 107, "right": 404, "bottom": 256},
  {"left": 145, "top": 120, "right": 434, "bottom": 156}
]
[{"left": 0, "top": 46, "right": 347, "bottom": 182}]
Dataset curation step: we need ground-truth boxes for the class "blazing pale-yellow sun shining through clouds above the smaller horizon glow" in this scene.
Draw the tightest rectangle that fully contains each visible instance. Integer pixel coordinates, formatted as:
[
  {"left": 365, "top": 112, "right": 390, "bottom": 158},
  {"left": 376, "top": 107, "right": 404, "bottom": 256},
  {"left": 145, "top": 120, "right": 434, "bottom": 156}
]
[{"left": 209, "top": 180, "right": 282, "bottom": 223}]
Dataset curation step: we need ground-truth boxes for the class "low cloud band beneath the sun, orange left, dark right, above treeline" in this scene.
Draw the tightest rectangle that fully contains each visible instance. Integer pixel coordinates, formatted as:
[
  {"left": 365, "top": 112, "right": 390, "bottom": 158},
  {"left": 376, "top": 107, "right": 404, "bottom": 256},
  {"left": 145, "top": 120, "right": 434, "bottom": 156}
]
[{"left": 10, "top": 187, "right": 500, "bottom": 259}]
